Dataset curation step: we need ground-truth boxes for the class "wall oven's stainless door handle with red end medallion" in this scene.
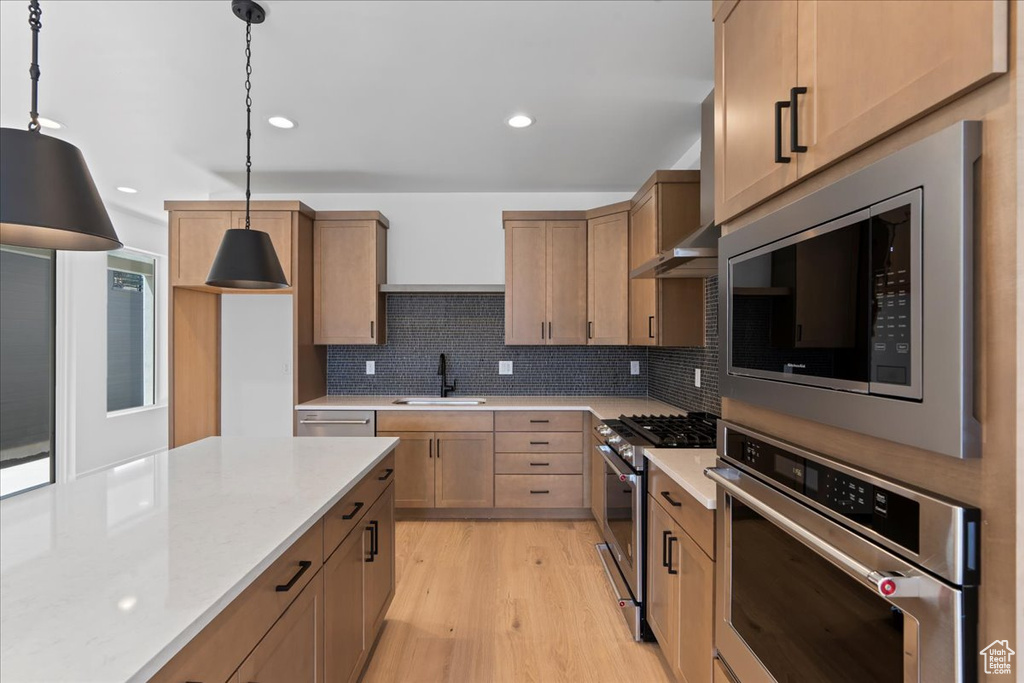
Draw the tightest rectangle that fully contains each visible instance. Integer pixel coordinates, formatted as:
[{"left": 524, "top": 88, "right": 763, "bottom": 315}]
[{"left": 705, "top": 467, "right": 921, "bottom": 598}]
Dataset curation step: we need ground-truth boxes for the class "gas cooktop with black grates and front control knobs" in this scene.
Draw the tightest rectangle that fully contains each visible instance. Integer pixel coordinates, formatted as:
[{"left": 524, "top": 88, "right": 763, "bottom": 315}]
[{"left": 597, "top": 413, "right": 718, "bottom": 471}]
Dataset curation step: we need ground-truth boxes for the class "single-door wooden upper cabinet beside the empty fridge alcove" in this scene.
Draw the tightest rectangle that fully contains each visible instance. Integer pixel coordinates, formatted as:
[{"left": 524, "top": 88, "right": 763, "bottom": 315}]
[{"left": 313, "top": 211, "right": 388, "bottom": 344}]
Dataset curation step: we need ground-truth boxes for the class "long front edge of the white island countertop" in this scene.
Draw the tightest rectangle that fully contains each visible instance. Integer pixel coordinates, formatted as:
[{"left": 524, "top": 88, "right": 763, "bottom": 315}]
[{"left": 128, "top": 436, "right": 398, "bottom": 682}]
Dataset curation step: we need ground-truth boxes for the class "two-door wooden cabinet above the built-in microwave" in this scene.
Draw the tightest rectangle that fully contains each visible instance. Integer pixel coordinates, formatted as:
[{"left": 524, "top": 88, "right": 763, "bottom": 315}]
[{"left": 714, "top": 0, "right": 1009, "bottom": 222}]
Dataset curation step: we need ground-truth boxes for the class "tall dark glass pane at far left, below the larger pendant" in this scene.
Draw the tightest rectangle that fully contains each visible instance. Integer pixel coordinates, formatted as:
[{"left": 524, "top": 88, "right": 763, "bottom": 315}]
[{"left": 0, "top": 246, "right": 56, "bottom": 496}]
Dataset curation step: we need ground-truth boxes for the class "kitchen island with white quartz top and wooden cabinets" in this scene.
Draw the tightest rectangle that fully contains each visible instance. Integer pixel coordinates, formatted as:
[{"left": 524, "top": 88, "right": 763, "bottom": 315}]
[{"left": 0, "top": 437, "right": 397, "bottom": 683}]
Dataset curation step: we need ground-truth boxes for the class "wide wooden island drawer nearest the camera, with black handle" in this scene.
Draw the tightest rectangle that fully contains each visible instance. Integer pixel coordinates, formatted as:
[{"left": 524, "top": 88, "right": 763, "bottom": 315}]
[{"left": 152, "top": 520, "right": 324, "bottom": 683}]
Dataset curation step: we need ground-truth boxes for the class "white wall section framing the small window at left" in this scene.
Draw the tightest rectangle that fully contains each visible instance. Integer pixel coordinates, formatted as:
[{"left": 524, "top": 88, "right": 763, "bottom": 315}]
[{"left": 56, "top": 205, "right": 168, "bottom": 481}]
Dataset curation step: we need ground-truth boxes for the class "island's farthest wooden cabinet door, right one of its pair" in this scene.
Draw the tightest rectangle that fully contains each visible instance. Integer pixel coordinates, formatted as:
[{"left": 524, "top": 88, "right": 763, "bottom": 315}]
[{"left": 364, "top": 486, "right": 394, "bottom": 649}]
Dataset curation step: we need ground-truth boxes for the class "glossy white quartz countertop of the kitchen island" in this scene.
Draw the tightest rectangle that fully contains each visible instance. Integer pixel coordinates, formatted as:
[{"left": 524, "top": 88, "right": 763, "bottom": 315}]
[{"left": 0, "top": 437, "right": 397, "bottom": 683}]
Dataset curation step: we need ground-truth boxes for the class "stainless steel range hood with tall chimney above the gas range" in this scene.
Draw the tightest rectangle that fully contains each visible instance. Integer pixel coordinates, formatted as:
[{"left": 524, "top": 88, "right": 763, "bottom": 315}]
[{"left": 630, "top": 90, "right": 722, "bottom": 279}]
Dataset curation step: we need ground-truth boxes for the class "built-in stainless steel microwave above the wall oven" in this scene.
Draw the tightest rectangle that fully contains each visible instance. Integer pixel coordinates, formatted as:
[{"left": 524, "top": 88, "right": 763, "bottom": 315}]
[{"left": 719, "top": 122, "right": 981, "bottom": 458}]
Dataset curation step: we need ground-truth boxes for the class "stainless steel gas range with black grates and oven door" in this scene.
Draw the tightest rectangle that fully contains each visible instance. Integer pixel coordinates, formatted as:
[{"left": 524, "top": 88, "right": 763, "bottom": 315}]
[{"left": 597, "top": 413, "right": 717, "bottom": 640}]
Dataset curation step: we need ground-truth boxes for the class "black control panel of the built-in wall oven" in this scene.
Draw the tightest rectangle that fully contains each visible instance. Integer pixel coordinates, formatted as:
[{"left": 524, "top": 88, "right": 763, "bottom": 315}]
[{"left": 726, "top": 432, "right": 921, "bottom": 553}]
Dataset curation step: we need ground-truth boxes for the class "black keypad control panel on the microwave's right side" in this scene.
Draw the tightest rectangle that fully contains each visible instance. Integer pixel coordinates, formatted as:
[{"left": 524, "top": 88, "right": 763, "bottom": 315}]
[{"left": 871, "top": 204, "right": 913, "bottom": 386}]
